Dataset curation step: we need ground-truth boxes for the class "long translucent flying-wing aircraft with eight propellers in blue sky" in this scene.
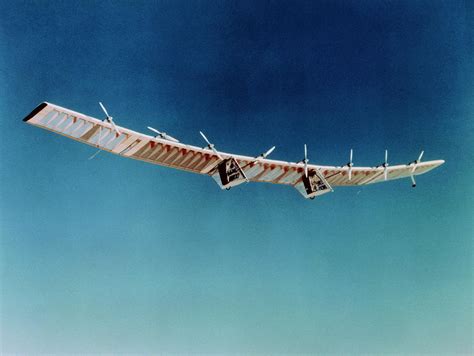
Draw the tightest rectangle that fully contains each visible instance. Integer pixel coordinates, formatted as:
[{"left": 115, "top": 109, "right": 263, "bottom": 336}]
[{"left": 23, "top": 102, "right": 444, "bottom": 199}]
